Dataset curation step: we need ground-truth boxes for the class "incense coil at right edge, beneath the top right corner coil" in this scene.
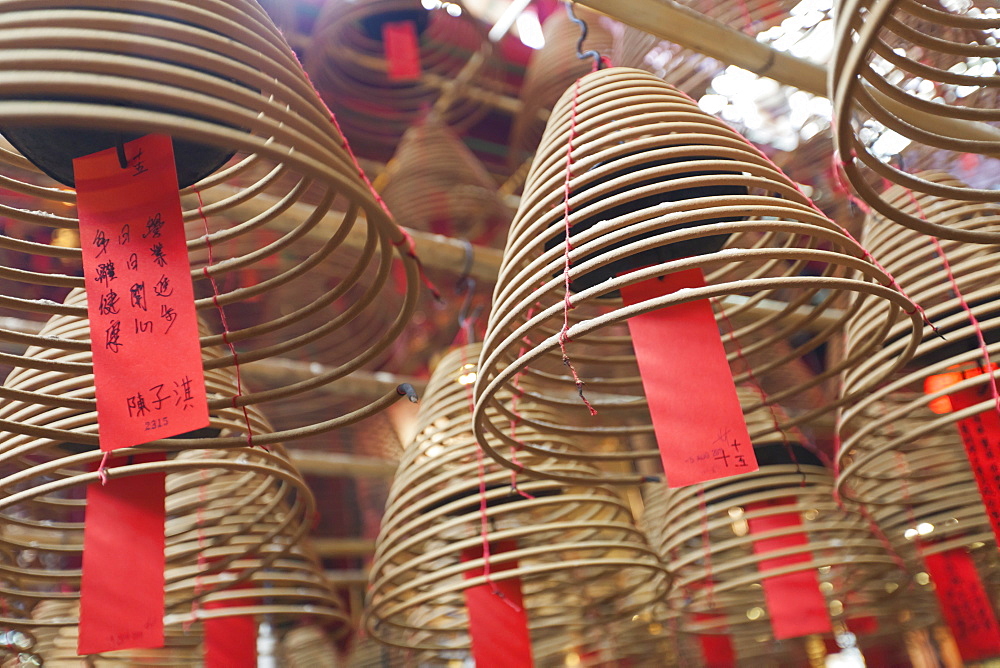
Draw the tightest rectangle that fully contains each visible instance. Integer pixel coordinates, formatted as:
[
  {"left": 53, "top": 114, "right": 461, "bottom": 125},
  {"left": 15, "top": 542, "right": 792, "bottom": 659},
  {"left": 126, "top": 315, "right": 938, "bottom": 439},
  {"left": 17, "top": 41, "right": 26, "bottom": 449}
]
[{"left": 838, "top": 172, "right": 1000, "bottom": 507}]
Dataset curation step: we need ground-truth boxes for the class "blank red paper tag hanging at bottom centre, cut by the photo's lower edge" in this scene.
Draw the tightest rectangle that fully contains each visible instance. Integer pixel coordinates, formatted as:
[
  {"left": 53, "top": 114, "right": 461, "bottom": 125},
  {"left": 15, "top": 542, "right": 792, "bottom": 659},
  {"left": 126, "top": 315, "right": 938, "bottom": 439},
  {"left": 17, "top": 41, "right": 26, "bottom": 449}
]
[{"left": 462, "top": 540, "right": 534, "bottom": 668}]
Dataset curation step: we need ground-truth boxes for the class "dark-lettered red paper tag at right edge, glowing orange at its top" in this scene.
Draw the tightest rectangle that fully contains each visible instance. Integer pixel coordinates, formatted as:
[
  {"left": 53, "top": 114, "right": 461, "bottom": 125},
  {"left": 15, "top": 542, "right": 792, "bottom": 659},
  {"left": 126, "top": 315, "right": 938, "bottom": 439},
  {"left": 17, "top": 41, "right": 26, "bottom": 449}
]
[{"left": 924, "top": 365, "right": 1000, "bottom": 540}]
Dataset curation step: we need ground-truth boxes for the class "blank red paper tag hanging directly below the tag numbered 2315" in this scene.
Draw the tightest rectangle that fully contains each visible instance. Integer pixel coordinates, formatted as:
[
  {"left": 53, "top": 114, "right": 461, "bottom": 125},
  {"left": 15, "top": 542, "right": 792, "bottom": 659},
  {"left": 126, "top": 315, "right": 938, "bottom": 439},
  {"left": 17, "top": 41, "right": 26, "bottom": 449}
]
[{"left": 77, "top": 453, "right": 166, "bottom": 655}]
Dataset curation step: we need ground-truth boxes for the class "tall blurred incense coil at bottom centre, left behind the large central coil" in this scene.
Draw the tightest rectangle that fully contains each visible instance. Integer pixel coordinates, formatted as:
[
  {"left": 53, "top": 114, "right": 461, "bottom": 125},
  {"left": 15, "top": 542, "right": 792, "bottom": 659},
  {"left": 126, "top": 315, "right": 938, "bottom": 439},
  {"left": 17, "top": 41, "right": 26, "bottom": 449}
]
[{"left": 363, "top": 346, "right": 666, "bottom": 652}]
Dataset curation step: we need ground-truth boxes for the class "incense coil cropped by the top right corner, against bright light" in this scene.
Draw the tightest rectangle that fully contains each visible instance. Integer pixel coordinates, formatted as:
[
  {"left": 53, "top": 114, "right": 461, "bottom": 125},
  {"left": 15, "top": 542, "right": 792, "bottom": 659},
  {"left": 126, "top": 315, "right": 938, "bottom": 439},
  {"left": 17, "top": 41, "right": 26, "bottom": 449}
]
[{"left": 830, "top": 0, "right": 1000, "bottom": 244}]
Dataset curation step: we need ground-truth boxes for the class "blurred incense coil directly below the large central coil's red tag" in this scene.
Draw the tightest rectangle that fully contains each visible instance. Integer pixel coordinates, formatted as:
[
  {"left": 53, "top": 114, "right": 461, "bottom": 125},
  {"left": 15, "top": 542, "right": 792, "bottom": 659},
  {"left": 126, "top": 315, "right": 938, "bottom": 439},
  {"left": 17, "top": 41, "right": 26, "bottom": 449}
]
[{"left": 643, "top": 460, "right": 909, "bottom": 638}]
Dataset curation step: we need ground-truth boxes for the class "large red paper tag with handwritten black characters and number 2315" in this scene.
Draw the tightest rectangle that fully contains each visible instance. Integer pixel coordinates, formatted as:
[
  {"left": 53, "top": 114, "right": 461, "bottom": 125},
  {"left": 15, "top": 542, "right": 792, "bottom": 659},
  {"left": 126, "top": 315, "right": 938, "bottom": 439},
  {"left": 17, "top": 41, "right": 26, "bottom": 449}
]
[{"left": 73, "top": 135, "right": 208, "bottom": 451}]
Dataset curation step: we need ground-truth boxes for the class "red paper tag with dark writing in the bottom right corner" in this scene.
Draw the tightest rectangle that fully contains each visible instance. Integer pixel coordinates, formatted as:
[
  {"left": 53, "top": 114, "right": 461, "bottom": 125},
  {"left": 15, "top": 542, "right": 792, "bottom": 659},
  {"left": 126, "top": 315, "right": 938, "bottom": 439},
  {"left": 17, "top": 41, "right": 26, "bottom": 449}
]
[{"left": 924, "top": 548, "right": 1000, "bottom": 661}]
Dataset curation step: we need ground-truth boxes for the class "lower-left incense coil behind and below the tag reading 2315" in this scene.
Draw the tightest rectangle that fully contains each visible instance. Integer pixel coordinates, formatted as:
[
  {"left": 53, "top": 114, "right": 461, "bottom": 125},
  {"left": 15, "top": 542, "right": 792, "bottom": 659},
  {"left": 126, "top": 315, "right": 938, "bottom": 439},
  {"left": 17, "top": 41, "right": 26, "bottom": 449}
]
[{"left": 0, "top": 293, "right": 343, "bottom": 625}]
